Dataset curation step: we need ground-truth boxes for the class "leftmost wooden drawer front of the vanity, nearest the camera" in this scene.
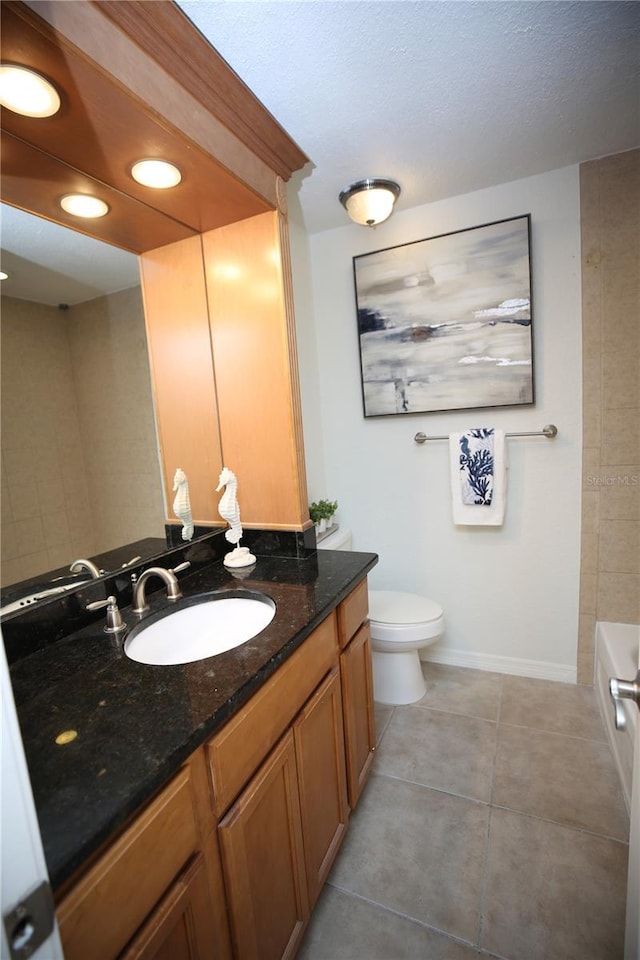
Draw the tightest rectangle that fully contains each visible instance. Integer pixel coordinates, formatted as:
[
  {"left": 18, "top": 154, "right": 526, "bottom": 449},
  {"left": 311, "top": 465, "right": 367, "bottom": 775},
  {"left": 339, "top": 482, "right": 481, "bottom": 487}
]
[{"left": 57, "top": 767, "right": 198, "bottom": 960}]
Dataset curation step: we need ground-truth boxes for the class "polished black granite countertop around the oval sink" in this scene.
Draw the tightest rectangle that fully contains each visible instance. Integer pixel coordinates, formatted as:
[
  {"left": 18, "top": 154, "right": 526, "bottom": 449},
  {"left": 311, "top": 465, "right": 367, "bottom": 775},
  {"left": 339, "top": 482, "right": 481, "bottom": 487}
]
[{"left": 10, "top": 550, "right": 377, "bottom": 890}]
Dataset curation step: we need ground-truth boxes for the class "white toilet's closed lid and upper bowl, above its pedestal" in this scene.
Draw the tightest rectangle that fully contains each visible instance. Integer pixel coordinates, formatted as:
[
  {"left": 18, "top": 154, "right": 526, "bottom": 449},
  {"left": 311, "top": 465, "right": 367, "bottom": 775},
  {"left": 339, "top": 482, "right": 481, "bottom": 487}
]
[{"left": 369, "top": 590, "right": 444, "bottom": 649}]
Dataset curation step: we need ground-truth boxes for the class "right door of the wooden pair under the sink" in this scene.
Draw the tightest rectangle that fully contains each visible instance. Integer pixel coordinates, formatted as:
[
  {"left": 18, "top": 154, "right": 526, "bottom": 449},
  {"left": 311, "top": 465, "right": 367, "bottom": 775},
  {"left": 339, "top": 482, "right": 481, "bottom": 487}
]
[{"left": 293, "top": 667, "right": 349, "bottom": 909}]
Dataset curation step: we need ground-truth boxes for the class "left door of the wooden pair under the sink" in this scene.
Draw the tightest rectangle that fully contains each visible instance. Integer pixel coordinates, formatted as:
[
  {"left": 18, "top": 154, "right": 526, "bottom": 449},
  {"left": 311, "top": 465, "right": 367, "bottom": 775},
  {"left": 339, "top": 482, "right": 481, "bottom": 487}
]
[{"left": 218, "top": 730, "right": 309, "bottom": 960}]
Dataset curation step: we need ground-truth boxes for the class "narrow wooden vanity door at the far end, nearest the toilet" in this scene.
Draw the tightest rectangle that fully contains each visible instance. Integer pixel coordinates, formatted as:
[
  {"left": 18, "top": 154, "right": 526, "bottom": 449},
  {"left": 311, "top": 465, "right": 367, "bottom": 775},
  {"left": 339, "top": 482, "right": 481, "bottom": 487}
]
[{"left": 340, "top": 623, "right": 376, "bottom": 810}]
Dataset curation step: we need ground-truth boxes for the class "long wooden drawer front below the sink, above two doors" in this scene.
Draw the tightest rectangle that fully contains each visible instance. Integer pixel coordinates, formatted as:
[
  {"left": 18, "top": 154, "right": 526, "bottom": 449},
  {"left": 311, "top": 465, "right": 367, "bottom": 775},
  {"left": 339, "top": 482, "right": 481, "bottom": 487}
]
[{"left": 207, "top": 613, "right": 338, "bottom": 816}]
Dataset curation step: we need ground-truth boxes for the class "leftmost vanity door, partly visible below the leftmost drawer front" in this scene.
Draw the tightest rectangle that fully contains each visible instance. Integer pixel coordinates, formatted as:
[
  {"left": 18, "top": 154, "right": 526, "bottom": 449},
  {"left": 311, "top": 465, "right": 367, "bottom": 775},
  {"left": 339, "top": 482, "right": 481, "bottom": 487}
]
[{"left": 120, "top": 854, "right": 219, "bottom": 960}]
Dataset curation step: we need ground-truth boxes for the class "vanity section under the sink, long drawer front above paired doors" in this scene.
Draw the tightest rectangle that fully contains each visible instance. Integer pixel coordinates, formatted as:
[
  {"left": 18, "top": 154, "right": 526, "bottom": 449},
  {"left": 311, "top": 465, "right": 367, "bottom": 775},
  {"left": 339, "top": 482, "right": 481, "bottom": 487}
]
[{"left": 207, "top": 614, "right": 349, "bottom": 960}]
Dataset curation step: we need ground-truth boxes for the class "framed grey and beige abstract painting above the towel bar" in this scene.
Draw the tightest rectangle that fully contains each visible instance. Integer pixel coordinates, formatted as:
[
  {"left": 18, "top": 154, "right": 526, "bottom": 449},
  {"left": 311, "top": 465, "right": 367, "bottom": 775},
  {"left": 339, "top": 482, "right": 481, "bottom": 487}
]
[{"left": 353, "top": 214, "right": 535, "bottom": 418}]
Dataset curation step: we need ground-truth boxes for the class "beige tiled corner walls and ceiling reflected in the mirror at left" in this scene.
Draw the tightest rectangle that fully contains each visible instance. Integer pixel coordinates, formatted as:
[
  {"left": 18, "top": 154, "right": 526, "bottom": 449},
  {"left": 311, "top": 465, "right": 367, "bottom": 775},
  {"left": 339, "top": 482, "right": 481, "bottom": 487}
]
[{"left": 0, "top": 207, "right": 164, "bottom": 586}]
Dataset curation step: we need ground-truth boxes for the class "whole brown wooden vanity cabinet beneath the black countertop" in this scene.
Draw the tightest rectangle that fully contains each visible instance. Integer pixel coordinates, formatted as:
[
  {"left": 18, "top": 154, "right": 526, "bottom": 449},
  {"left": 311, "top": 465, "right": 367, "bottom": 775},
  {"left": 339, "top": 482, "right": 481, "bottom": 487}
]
[{"left": 57, "top": 579, "right": 375, "bottom": 960}]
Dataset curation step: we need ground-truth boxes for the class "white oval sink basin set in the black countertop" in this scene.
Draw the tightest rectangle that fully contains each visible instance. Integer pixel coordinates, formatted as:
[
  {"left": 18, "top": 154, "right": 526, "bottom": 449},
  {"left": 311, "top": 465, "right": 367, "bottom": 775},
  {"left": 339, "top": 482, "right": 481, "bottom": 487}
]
[{"left": 124, "top": 593, "right": 276, "bottom": 665}]
